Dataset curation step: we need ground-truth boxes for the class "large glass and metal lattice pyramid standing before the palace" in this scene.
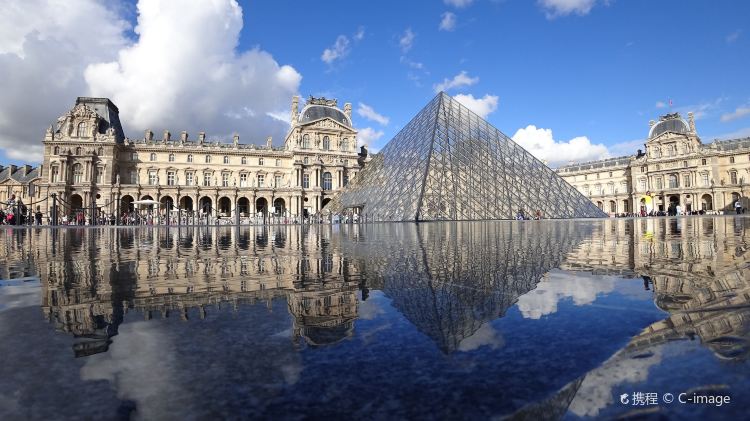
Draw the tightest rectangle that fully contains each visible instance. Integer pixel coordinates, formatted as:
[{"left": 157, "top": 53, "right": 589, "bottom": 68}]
[{"left": 326, "top": 92, "right": 606, "bottom": 221}]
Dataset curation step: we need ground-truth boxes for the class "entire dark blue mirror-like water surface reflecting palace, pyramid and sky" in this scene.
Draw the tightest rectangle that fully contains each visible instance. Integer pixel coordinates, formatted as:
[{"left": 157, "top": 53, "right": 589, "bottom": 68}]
[{"left": 0, "top": 217, "right": 750, "bottom": 420}]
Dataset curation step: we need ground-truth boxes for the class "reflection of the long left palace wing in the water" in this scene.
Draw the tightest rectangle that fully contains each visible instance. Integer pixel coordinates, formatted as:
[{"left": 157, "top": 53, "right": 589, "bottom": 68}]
[{"left": 6, "top": 227, "right": 360, "bottom": 356}]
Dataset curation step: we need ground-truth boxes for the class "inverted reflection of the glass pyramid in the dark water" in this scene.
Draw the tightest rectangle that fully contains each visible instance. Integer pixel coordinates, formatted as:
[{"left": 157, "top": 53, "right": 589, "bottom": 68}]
[{"left": 355, "top": 222, "right": 590, "bottom": 352}]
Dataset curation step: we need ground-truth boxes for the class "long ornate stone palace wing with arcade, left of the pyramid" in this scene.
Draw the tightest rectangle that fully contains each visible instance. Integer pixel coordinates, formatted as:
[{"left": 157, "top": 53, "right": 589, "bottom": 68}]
[{"left": 27, "top": 96, "right": 366, "bottom": 217}]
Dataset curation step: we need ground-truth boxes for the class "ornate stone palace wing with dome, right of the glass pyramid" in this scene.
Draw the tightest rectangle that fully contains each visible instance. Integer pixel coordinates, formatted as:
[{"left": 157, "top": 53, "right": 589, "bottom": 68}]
[{"left": 557, "top": 113, "right": 750, "bottom": 215}]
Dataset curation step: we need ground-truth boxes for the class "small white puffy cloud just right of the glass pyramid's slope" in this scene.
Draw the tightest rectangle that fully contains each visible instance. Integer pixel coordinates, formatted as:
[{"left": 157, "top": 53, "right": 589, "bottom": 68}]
[{"left": 512, "top": 124, "right": 610, "bottom": 167}]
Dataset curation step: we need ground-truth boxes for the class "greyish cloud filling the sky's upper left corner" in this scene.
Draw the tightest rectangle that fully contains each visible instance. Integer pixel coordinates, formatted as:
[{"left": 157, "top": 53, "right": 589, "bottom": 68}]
[{"left": 0, "top": 0, "right": 130, "bottom": 163}]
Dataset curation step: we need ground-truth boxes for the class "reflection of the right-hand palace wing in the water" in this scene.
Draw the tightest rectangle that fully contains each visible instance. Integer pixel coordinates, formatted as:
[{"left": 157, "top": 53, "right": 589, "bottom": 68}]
[{"left": 562, "top": 218, "right": 750, "bottom": 359}]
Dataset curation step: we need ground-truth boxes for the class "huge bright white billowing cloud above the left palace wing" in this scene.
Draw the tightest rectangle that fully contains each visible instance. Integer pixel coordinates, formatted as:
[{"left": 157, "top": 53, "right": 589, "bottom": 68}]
[{"left": 85, "top": 0, "right": 302, "bottom": 148}]
